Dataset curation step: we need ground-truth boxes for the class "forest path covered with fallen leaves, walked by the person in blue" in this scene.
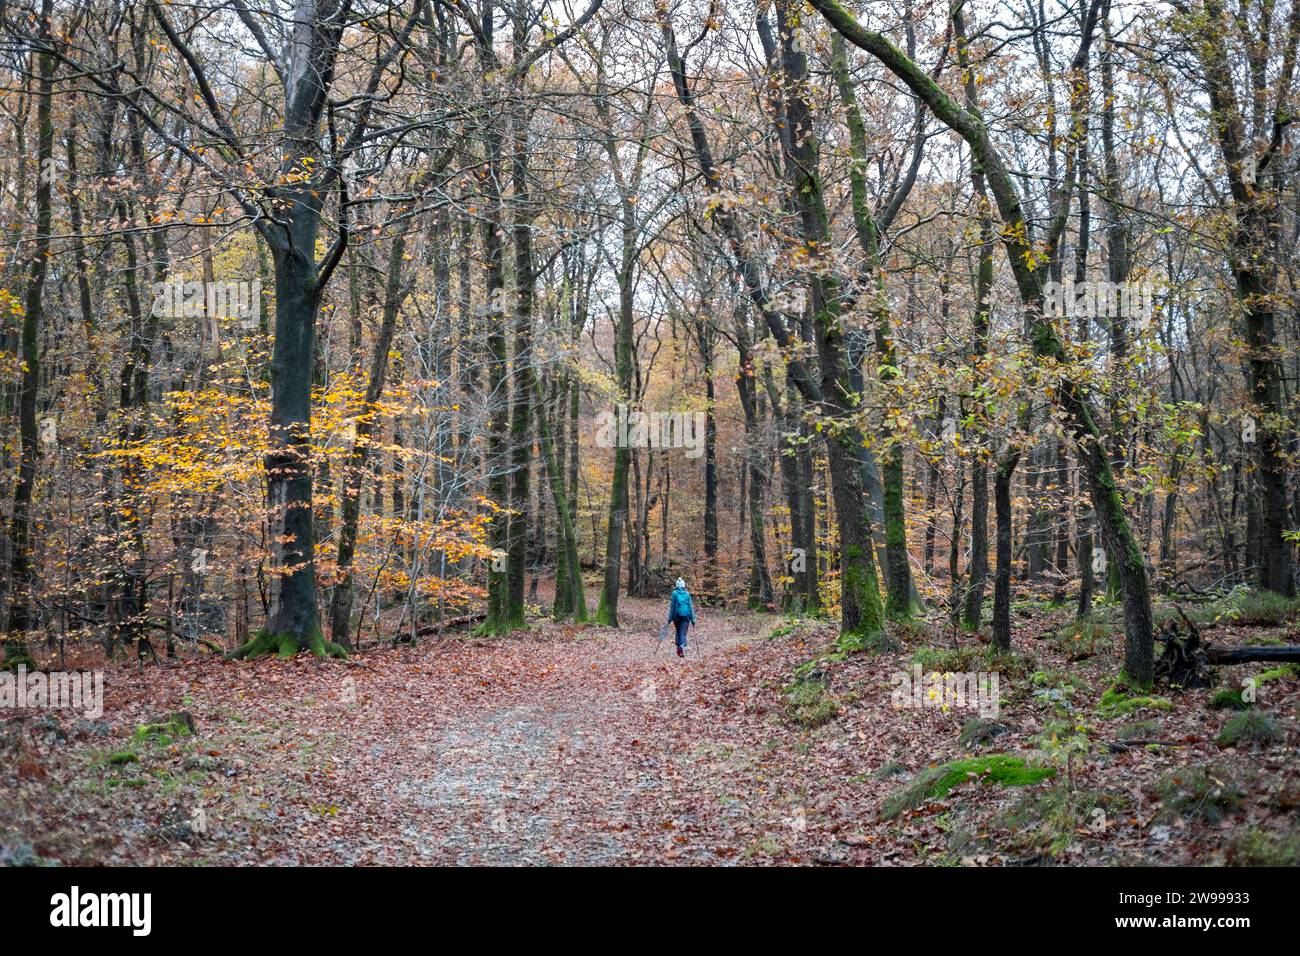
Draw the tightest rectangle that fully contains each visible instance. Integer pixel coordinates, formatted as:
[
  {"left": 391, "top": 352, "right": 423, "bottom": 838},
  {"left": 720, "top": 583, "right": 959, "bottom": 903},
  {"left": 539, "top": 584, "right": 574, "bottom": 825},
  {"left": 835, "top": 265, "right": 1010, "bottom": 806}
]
[{"left": 318, "top": 598, "right": 759, "bottom": 865}]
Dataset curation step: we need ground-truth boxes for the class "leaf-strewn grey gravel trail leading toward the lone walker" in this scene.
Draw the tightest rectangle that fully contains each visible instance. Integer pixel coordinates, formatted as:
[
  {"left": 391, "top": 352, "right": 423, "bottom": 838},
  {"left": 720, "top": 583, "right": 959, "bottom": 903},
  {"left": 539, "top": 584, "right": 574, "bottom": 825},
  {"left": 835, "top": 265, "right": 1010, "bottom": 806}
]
[{"left": 340, "top": 598, "right": 754, "bottom": 864}]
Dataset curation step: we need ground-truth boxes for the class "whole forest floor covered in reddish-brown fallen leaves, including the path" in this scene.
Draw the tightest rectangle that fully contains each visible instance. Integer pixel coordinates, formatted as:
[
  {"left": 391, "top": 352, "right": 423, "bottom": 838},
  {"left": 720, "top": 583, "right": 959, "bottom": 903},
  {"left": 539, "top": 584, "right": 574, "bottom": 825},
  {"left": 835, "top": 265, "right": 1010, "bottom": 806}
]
[{"left": 0, "top": 582, "right": 1300, "bottom": 865}]
